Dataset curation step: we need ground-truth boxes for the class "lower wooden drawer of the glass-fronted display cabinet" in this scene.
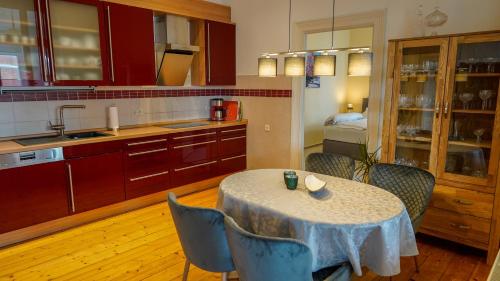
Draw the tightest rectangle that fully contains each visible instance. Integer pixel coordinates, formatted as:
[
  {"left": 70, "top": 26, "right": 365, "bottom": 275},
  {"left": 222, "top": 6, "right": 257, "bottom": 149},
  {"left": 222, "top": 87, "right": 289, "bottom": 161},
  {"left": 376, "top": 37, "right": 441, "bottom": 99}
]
[{"left": 421, "top": 207, "right": 491, "bottom": 247}]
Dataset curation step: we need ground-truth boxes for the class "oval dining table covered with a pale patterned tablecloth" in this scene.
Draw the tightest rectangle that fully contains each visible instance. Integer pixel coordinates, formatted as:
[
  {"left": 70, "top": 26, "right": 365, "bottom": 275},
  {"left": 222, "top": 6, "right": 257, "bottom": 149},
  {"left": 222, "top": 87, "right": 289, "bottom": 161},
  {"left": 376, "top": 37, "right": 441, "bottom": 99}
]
[{"left": 217, "top": 169, "right": 418, "bottom": 276}]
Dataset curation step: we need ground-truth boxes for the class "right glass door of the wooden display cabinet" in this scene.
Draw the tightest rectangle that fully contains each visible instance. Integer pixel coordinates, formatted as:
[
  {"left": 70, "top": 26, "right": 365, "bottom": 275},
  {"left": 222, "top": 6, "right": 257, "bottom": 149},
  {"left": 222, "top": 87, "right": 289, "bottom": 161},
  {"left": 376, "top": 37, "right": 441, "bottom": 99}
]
[{"left": 439, "top": 34, "right": 500, "bottom": 185}]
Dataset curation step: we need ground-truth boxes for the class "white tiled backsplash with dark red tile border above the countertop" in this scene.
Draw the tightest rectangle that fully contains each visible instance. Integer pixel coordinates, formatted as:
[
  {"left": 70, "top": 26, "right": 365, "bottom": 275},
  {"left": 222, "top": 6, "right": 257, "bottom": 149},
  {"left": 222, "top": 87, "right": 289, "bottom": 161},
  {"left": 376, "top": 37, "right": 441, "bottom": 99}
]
[{"left": 0, "top": 89, "right": 291, "bottom": 137}]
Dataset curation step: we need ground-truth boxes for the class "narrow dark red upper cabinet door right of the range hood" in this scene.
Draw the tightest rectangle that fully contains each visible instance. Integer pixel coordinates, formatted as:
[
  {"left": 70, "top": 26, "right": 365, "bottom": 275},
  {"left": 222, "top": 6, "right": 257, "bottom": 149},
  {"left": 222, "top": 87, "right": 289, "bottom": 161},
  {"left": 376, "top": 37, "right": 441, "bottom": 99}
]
[{"left": 205, "top": 21, "right": 236, "bottom": 85}]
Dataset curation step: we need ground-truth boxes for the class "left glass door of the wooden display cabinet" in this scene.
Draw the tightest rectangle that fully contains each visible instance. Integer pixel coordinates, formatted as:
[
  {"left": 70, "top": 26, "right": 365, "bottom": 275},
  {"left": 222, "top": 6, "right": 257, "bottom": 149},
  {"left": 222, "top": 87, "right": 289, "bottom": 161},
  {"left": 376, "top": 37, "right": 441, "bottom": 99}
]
[{"left": 389, "top": 38, "right": 448, "bottom": 174}]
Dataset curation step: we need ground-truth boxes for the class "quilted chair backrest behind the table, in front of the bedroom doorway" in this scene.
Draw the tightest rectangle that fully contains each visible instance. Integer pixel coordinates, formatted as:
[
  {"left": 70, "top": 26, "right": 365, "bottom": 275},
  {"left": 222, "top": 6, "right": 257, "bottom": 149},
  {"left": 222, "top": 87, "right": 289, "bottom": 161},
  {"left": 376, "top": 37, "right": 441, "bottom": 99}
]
[{"left": 306, "top": 153, "right": 354, "bottom": 180}]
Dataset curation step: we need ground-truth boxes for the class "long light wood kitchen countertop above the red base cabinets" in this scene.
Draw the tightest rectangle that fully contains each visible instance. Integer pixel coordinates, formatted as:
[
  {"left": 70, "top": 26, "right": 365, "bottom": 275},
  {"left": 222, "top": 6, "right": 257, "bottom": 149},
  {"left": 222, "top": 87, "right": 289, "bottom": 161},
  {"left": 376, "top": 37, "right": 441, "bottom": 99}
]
[{"left": 0, "top": 119, "right": 248, "bottom": 154}]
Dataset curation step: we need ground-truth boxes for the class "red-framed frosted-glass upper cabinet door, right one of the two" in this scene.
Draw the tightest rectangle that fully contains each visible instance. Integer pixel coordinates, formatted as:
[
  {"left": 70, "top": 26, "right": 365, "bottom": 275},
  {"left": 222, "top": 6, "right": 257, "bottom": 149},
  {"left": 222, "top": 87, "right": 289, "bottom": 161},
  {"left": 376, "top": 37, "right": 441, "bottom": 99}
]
[{"left": 45, "top": 0, "right": 109, "bottom": 86}]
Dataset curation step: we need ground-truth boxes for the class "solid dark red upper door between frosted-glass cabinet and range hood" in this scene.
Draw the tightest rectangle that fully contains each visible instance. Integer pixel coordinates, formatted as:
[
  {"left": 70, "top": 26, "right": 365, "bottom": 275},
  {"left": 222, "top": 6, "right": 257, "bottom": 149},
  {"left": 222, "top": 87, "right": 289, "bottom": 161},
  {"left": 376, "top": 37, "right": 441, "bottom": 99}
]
[{"left": 105, "top": 3, "right": 156, "bottom": 86}]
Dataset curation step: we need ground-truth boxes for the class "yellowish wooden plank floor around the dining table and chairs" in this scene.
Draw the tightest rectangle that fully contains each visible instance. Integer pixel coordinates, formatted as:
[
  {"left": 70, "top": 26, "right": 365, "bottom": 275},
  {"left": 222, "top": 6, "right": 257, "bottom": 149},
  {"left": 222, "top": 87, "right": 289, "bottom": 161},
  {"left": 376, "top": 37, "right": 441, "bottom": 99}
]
[{"left": 0, "top": 189, "right": 489, "bottom": 281}]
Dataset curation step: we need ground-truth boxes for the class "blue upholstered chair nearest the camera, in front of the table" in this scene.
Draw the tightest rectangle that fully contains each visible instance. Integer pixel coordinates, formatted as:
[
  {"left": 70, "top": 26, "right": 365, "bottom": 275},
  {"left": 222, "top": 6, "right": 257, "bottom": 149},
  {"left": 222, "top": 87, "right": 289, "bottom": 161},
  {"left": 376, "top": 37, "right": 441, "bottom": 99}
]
[{"left": 225, "top": 217, "right": 352, "bottom": 281}]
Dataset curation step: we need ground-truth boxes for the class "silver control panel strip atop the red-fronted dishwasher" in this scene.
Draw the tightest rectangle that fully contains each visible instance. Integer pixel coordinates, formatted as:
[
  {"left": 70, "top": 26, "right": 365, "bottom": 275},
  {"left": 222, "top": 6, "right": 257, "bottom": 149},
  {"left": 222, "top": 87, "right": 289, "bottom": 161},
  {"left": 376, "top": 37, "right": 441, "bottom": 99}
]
[{"left": 0, "top": 147, "right": 64, "bottom": 170}]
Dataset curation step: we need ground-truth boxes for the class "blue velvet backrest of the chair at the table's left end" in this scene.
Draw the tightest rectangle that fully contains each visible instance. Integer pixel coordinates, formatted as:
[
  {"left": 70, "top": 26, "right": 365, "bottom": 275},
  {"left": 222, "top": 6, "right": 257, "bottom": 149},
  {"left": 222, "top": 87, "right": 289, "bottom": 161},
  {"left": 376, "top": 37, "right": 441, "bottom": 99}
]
[{"left": 168, "top": 192, "right": 234, "bottom": 272}]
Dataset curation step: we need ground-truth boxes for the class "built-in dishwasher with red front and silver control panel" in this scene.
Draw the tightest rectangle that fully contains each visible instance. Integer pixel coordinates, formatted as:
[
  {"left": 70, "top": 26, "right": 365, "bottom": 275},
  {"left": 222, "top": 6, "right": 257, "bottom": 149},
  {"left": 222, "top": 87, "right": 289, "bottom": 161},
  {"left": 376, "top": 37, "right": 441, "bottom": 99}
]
[{"left": 0, "top": 147, "right": 69, "bottom": 233}]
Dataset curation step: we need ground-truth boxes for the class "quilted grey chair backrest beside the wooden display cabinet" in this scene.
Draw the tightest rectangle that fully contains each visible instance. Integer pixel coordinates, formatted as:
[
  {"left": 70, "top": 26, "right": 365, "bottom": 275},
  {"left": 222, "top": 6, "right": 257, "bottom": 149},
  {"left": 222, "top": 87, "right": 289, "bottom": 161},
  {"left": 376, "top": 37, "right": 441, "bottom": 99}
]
[{"left": 368, "top": 164, "right": 435, "bottom": 232}]
